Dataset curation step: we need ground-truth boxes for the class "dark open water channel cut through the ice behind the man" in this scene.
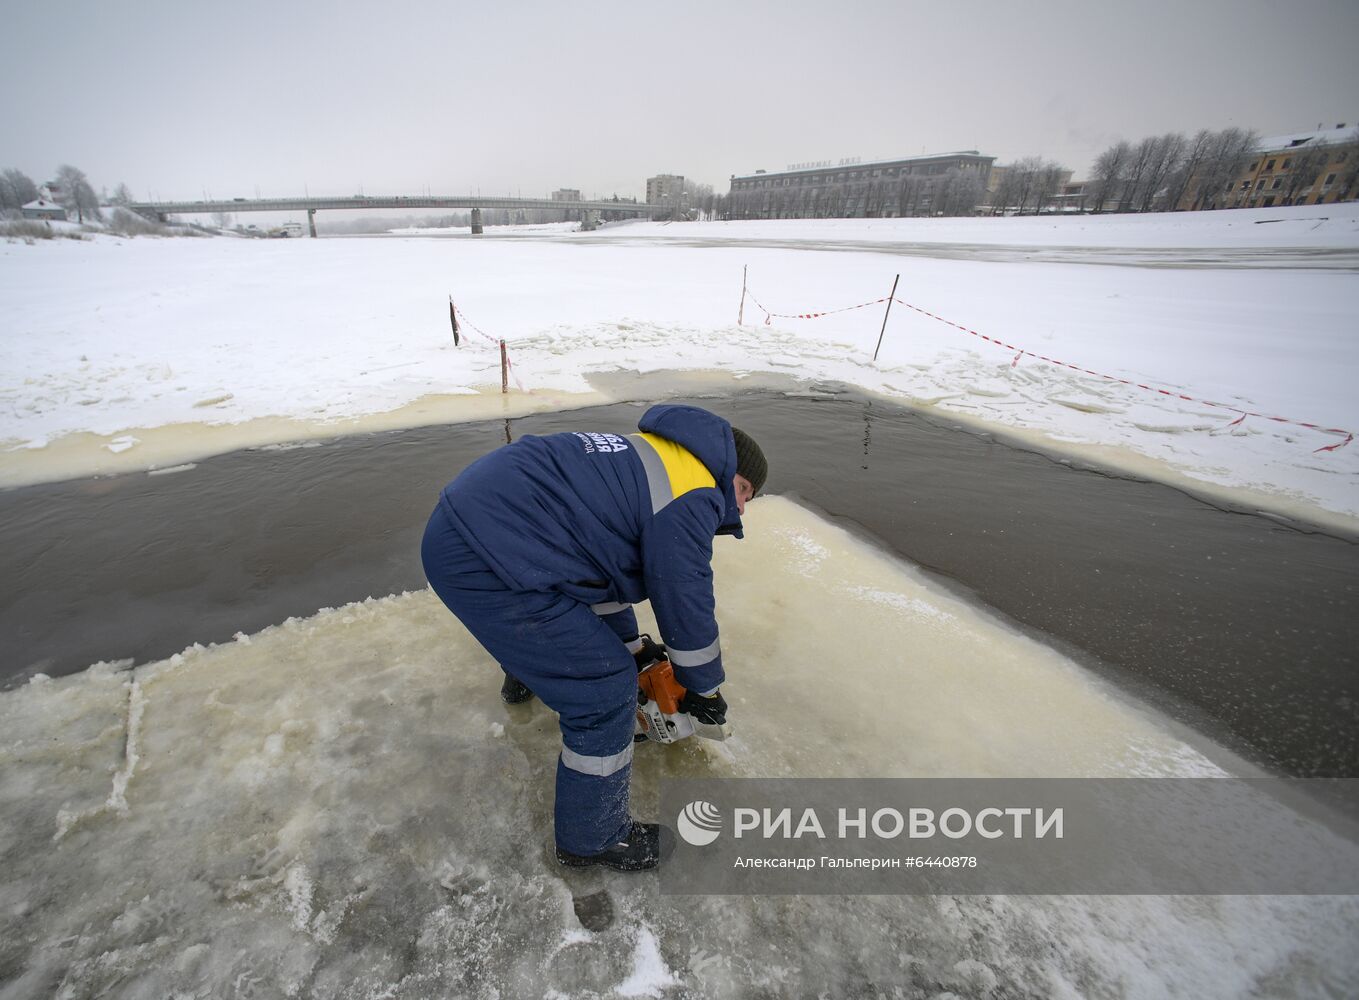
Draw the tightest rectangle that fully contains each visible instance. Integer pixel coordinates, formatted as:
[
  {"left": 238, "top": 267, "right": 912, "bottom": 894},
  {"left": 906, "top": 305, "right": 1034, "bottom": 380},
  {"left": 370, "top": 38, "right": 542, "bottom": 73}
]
[{"left": 0, "top": 391, "right": 1359, "bottom": 777}]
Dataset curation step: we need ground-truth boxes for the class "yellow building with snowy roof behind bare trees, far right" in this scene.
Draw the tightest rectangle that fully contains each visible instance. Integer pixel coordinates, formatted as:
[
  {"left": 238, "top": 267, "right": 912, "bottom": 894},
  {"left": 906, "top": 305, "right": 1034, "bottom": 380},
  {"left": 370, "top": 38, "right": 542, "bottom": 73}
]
[{"left": 1177, "top": 122, "right": 1359, "bottom": 209}]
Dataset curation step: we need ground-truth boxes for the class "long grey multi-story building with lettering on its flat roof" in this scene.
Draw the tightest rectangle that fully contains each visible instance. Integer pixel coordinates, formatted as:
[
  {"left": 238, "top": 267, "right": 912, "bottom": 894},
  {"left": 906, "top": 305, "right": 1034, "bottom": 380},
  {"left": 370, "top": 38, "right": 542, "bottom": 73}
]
[{"left": 728, "top": 149, "right": 996, "bottom": 219}]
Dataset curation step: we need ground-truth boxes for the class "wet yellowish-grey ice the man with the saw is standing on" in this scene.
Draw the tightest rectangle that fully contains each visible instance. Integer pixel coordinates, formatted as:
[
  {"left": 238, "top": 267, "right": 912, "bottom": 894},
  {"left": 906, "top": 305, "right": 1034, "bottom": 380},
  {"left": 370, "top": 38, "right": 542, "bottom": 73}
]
[{"left": 0, "top": 497, "right": 1359, "bottom": 1000}]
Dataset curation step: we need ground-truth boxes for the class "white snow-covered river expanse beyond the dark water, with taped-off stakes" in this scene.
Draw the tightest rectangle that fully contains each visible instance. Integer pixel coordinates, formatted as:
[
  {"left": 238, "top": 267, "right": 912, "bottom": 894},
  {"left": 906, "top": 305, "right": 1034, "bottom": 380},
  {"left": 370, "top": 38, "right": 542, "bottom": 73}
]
[{"left": 0, "top": 205, "right": 1359, "bottom": 527}]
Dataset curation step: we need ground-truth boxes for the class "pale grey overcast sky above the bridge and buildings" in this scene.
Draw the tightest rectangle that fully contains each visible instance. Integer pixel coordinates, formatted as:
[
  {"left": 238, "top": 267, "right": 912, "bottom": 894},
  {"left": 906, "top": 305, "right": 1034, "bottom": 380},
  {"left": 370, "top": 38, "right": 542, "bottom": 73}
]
[{"left": 0, "top": 0, "right": 1359, "bottom": 198}]
